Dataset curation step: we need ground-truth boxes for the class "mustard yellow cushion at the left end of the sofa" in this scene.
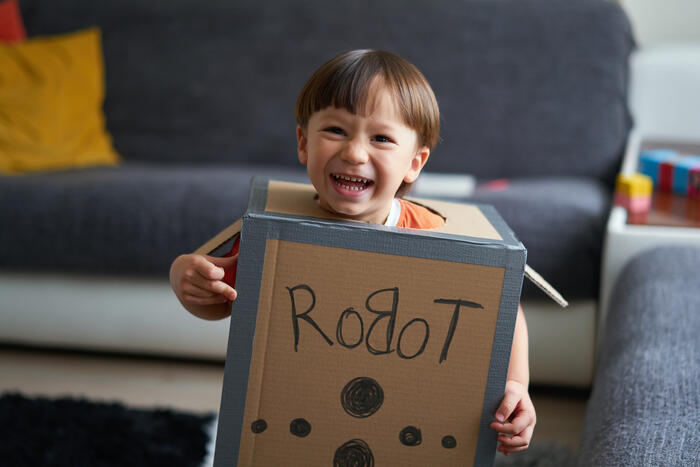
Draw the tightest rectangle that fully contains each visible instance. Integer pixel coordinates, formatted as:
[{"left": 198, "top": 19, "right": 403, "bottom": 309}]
[{"left": 0, "top": 28, "right": 119, "bottom": 174}]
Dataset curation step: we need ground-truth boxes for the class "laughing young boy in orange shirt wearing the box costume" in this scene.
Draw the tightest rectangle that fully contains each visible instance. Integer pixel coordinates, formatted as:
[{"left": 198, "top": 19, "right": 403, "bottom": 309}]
[{"left": 170, "top": 50, "right": 536, "bottom": 455}]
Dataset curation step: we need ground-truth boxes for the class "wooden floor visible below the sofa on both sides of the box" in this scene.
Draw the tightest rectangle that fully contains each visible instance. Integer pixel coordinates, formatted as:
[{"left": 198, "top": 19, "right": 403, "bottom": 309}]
[{"left": 0, "top": 347, "right": 587, "bottom": 450}]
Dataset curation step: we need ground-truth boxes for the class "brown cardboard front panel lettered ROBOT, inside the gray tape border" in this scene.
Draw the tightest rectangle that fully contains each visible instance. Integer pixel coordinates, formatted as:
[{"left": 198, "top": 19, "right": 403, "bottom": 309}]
[{"left": 239, "top": 240, "right": 504, "bottom": 466}]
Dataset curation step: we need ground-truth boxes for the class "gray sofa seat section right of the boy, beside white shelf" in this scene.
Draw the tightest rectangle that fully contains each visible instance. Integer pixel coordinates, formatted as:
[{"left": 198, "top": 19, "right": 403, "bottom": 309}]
[{"left": 468, "top": 177, "right": 610, "bottom": 300}]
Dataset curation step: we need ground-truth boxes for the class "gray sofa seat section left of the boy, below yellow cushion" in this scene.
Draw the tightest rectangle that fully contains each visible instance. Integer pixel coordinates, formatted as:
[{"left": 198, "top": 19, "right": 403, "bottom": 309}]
[{"left": 0, "top": 163, "right": 306, "bottom": 275}]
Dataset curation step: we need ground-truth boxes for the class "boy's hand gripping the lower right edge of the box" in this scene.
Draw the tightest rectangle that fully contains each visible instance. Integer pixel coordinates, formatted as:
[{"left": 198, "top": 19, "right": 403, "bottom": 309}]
[{"left": 491, "top": 380, "right": 537, "bottom": 456}]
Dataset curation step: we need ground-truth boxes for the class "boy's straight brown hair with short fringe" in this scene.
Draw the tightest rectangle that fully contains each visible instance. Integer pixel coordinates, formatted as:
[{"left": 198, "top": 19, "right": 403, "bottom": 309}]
[{"left": 295, "top": 50, "right": 440, "bottom": 195}]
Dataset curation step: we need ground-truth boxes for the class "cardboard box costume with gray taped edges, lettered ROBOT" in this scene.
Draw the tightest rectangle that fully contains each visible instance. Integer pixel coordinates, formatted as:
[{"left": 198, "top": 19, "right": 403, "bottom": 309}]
[{"left": 206, "top": 179, "right": 552, "bottom": 467}]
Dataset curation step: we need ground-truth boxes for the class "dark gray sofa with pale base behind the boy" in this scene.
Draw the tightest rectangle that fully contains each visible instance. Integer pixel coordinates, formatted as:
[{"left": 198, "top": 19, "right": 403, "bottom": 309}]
[{"left": 0, "top": 0, "right": 633, "bottom": 385}]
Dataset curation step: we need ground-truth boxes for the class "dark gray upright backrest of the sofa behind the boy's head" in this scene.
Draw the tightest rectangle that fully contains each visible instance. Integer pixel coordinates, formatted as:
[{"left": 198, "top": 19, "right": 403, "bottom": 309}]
[{"left": 21, "top": 0, "right": 633, "bottom": 183}]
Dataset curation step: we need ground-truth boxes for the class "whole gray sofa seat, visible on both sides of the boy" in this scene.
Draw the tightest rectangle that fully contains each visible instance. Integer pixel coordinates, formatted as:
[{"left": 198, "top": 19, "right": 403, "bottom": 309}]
[{"left": 0, "top": 171, "right": 608, "bottom": 298}]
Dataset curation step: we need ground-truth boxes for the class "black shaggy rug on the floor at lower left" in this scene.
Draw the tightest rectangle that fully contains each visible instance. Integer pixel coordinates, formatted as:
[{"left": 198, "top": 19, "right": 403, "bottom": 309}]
[{"left": 0, "top": 394, "right": 213, "bottom": 467}]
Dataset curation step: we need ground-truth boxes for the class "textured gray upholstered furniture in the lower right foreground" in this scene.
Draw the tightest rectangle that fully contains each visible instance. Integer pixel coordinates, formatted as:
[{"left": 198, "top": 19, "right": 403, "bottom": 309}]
[{"left": 579, "top": 247, "right": 700, "bottom": 467}]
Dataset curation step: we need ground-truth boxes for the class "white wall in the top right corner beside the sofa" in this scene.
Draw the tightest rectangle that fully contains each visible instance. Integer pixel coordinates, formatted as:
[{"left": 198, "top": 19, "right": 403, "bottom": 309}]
[{"left": 619, "top": 0, "right": 700, "bottom": 47}]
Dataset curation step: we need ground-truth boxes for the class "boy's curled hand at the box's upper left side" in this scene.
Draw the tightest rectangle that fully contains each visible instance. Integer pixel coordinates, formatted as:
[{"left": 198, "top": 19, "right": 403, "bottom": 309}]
[{"left": 170, "top": 254, "right": 238, "bottom": 305}]
